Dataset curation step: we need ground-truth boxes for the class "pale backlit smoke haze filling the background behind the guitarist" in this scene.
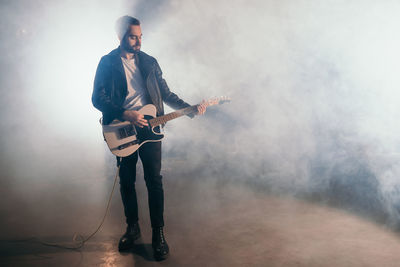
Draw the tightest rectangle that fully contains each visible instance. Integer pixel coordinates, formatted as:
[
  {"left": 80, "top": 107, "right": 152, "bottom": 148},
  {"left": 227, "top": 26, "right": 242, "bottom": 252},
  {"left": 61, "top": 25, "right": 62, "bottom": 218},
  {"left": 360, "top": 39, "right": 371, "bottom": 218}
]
[{"left": 0, "top": 0, "right": 400, "bottom": 239}]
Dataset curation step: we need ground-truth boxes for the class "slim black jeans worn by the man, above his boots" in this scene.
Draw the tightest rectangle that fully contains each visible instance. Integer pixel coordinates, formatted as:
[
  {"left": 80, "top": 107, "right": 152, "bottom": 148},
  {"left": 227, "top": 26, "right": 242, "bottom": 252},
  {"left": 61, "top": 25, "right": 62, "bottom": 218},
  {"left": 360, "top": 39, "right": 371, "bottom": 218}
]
[{"left": 119, "top": 142, "right": 164, "bottom": 228}]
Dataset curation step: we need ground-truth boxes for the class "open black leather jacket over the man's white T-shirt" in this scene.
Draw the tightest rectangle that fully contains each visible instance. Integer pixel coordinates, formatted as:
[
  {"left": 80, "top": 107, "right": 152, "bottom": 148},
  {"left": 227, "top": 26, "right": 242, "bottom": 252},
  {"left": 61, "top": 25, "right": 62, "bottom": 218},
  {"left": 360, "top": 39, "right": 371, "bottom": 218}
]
[{"left": 92, "top": 48, "right": 190, "bottom": 124}]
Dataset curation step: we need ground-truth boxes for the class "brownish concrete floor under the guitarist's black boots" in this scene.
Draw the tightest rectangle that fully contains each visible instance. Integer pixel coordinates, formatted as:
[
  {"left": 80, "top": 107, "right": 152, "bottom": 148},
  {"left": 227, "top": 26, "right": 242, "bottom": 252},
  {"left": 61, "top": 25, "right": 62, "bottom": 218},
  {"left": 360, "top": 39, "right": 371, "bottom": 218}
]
[{"left": 0, "top": 166, "right": 400, "bottom": 267}]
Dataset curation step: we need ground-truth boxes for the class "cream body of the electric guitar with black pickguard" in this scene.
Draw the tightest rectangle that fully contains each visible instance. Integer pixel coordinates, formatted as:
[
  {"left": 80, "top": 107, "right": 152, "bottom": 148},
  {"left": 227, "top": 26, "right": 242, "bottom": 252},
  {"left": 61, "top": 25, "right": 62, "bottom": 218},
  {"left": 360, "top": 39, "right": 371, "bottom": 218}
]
[{"left": 102, "top": 104, "right": 164, "bottom": 157}]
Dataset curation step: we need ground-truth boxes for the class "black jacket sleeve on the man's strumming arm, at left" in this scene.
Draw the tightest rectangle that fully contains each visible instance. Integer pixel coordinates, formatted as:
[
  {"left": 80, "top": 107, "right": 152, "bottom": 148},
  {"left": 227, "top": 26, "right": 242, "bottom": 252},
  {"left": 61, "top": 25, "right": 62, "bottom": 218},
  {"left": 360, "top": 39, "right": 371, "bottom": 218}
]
[{"left": 92, "top": 57, "right": 125, "bottom": 119}]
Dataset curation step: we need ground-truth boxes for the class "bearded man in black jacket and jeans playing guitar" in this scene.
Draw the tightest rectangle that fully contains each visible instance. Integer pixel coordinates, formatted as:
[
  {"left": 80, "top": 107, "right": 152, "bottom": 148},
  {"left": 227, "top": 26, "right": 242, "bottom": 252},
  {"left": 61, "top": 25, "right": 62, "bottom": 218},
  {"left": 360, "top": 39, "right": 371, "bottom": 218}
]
[{"left": 92, "top": 16, "right": 206, "bottom": 259}]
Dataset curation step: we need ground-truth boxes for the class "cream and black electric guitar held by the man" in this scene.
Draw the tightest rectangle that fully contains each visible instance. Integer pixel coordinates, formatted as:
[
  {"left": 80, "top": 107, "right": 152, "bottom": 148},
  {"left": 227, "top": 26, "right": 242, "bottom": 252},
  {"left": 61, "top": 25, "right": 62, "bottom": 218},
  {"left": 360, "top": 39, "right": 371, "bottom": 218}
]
[{"left": 100, "top": 97, "right": 230, "bottom": 157}]
